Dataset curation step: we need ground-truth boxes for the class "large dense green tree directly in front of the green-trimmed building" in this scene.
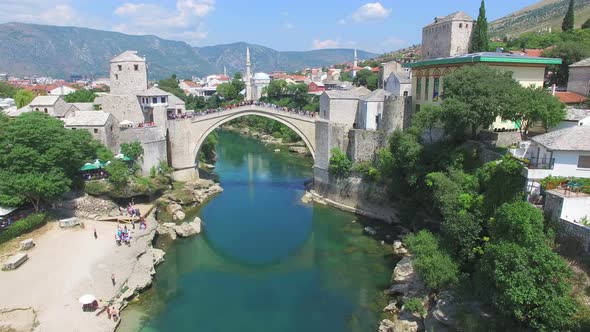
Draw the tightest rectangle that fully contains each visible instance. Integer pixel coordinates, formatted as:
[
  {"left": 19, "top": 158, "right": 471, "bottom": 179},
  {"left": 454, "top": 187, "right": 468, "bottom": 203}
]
[{"left": 442, "top": 64, "right": 520, "bottom": 138}]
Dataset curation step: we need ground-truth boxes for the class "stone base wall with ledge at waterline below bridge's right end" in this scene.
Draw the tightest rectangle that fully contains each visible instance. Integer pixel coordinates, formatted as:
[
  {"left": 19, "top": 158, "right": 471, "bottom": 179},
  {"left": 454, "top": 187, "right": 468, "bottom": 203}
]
[{"left": 313, "top": 168, "right": 399, "bottom": 223}]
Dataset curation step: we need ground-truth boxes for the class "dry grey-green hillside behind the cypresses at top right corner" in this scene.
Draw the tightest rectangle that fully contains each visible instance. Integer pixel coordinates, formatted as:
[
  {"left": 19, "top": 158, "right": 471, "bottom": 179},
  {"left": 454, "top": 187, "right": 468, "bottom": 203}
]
[{"left": 490, "top": 0, "right": 590, "bottom": 37}]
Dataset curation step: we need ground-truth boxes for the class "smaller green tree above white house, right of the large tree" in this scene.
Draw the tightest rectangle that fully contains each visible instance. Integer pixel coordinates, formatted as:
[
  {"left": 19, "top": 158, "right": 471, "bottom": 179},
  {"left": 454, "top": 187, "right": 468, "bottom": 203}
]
[{"left": 501, "top": 87, "right": 566, "bottom": 138}]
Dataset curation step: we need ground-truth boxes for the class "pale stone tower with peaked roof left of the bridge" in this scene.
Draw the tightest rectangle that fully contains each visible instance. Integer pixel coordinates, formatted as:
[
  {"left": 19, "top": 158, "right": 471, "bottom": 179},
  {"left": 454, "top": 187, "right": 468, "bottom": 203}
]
[{"left": 110, "top": 51, "right": 147, "bottom": 96}]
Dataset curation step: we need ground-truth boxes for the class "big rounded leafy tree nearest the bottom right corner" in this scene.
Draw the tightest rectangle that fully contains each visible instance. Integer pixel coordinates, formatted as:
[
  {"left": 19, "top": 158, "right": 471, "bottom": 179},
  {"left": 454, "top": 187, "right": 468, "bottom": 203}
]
[{"left": 479, "top": 241, "right": 577, "bottom": 331}]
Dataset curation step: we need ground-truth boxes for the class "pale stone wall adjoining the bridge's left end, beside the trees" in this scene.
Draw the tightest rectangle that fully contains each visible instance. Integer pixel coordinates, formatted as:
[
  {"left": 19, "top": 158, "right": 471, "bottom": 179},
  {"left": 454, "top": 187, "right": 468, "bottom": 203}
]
[{"left": 119, "top": 127, "right": 168, "bottom": 174}]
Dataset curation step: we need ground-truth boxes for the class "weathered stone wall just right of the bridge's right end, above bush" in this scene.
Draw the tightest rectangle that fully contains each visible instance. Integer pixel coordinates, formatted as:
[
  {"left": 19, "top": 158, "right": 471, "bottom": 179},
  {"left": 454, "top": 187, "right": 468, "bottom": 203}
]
[{"left": 346, "top": 129, "right": 387, "bottom": 162}]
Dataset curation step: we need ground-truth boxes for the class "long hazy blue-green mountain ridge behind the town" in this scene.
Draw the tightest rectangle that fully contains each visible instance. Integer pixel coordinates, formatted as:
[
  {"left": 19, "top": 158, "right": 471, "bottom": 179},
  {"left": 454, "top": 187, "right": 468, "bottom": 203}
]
[{"left": 0, "top": 23, "right": 376, "bottom": 79}]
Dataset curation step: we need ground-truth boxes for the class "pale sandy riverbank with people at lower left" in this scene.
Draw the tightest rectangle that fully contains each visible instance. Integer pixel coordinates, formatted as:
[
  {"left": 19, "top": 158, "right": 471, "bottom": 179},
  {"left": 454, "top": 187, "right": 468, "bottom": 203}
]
[{"left": 0, "top": 216, "right": 163, "bottom": 332}]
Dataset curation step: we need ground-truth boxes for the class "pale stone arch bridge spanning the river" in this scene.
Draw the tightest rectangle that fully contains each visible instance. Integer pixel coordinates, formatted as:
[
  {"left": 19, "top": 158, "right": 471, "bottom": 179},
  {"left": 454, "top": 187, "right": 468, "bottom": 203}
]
[{"left": 167, "top": 105, "right": 321, "bottom": 181}]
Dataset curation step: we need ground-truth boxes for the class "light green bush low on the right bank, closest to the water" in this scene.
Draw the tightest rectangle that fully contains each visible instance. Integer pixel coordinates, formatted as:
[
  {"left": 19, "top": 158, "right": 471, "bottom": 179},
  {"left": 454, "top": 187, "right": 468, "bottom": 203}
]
[{"left": 404, "top": 230, "right": 459, "bottom": 291}]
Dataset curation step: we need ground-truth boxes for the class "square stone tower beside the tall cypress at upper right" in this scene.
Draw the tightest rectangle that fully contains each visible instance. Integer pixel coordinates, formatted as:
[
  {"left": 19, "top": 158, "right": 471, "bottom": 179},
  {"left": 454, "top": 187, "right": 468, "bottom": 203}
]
[{"left": 422, "top": 12, "right": 475, "bottom": 60}]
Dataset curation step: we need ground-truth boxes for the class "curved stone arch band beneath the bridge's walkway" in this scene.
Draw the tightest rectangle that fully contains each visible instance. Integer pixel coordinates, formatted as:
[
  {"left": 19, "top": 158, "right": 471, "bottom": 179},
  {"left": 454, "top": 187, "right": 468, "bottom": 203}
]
[{"left": 193, "top": 109, "right": 315, "bottom": 160}]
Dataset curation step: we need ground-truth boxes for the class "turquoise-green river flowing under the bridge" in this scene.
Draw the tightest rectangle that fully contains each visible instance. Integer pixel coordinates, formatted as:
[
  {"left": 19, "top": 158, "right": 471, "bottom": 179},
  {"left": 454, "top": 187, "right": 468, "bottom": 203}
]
[{"left": 117, "top": 131, "right": 393, "bottom": 332}]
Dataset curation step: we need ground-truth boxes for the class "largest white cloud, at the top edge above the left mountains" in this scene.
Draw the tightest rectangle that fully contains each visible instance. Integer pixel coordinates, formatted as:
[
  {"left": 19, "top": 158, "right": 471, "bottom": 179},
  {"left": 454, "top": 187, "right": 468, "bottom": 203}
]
[{"left": 113, "top": 0, "right": 215, "bottom": 43}]
